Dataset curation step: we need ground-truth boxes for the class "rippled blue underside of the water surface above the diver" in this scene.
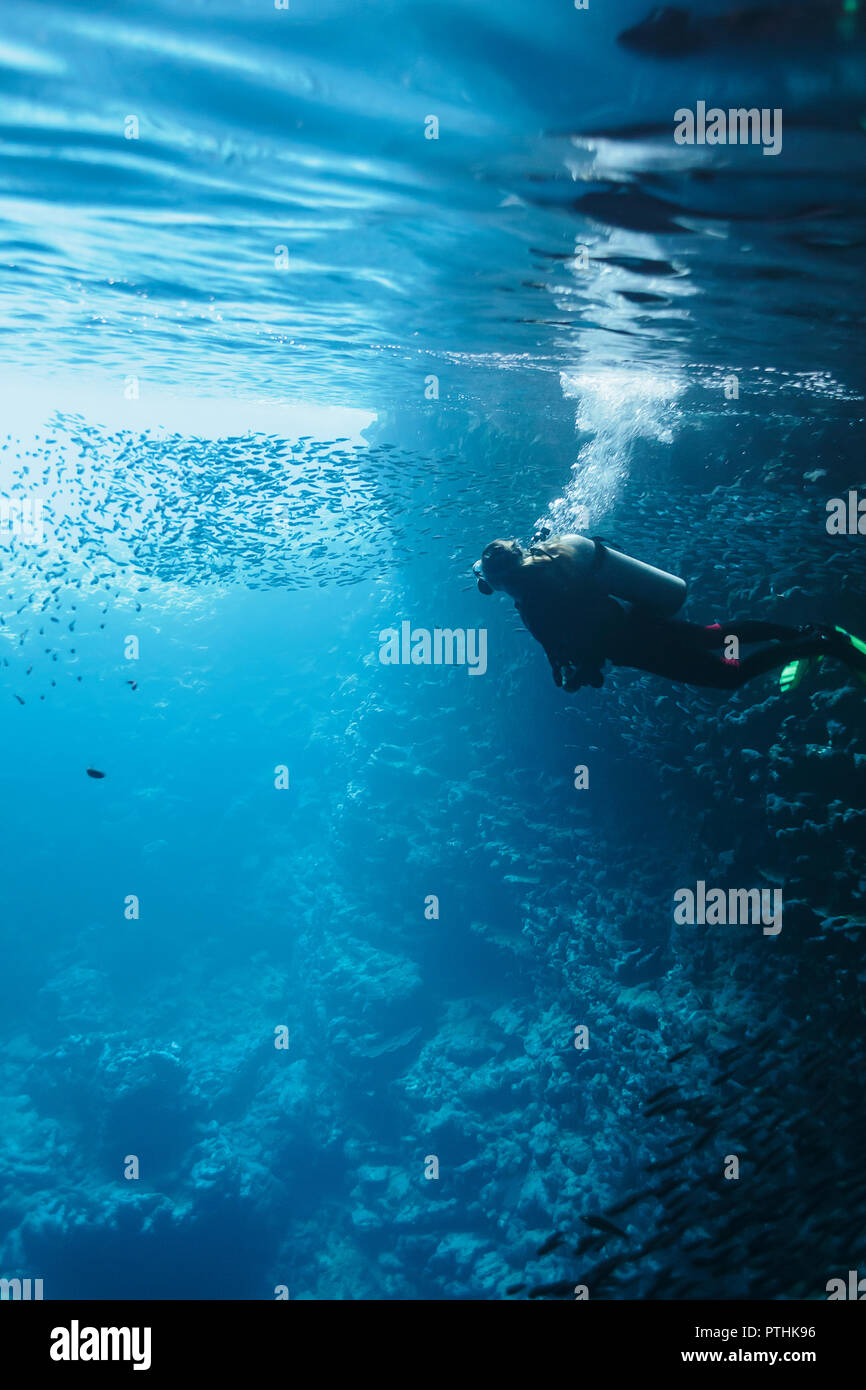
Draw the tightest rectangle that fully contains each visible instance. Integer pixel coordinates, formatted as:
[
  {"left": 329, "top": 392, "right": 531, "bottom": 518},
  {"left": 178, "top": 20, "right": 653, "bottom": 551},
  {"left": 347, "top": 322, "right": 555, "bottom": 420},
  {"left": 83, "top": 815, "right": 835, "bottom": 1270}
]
[{"left": 0, "top": 0, "right": 863, "bottom": 406}]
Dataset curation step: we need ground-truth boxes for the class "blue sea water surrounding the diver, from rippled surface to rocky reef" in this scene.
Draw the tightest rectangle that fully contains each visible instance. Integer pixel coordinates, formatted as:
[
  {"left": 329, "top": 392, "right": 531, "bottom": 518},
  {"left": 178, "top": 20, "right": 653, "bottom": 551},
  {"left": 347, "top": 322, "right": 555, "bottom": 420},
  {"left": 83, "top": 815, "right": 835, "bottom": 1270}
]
[{"left": 0, "top": 0, "right": 866, "bottom": 1300}]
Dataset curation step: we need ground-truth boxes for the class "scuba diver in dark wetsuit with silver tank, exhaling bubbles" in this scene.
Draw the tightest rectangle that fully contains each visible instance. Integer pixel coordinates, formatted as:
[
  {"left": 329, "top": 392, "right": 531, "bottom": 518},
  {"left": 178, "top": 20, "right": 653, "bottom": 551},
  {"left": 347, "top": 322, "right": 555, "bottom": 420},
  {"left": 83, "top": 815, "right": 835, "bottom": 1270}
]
[{"left": 474, "top": 530, "right": 866, "bottom": 691}]
